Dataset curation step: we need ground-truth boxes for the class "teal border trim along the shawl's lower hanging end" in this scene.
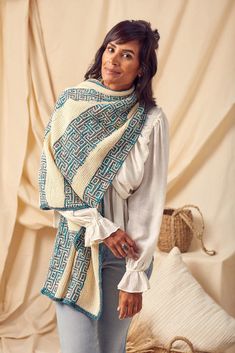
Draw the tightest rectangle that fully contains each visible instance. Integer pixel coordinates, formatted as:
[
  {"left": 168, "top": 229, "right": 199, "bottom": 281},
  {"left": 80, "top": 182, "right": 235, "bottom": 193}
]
[{"left": 40, "top": 244, "right": 104, "bottom": 320}]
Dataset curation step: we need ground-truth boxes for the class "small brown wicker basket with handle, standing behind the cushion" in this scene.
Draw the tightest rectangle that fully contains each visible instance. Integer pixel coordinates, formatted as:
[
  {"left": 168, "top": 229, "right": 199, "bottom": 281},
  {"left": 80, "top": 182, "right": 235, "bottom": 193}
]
[{"left": 158, "top": 205, "right": 216, "bottom": 255}]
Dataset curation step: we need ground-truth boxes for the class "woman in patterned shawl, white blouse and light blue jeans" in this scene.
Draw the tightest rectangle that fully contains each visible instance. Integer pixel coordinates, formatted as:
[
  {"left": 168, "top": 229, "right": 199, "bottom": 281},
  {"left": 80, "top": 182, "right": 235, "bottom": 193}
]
[{"left": 39, "top": 21, "right": 169, "bottom": 353}]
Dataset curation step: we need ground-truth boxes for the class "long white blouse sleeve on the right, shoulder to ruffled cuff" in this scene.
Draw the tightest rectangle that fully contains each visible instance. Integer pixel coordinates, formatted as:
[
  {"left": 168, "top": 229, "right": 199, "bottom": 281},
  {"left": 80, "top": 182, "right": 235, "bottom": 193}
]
[{"left": 118, "top": 111, "right": 169, "bottom": 293}]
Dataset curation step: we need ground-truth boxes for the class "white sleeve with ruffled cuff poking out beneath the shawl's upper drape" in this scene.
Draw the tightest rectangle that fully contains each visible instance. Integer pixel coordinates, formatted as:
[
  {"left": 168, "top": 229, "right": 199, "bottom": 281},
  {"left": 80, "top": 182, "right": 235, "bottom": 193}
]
[{"left": 54, "top": 208, "right": 120, "bottom": 246}]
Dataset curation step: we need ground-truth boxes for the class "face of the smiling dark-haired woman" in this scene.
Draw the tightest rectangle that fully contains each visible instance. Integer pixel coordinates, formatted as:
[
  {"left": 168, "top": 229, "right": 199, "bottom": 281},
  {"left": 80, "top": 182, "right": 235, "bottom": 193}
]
[{"left": 101, "top": 40, "right": 141, "bottom": 91}]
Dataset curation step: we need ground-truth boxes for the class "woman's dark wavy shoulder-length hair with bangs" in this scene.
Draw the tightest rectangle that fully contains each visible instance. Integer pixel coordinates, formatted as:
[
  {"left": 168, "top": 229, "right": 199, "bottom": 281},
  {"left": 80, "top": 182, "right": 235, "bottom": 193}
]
[{"left": 85, "top": 20, "right": 160, "bottom": 110}]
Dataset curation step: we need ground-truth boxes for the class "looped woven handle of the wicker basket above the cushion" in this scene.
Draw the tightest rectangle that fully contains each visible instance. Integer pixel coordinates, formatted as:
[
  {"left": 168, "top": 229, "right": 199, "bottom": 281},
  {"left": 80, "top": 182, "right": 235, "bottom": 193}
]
[{"left": 171, "top": 205, "right": 216, "bottom": 256}]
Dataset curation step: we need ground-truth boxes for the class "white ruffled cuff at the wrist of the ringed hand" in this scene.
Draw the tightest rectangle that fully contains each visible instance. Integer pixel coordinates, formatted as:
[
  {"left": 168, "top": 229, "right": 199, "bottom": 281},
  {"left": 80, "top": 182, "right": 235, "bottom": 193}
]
[{"left": 85, "top": 212, "right": 120, "bottom": 246}]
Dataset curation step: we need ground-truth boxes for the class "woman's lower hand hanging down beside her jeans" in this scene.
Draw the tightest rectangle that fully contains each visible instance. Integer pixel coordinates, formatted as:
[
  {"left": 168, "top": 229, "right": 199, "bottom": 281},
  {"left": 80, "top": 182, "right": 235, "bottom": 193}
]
[{"left": 117, "top": 290, "right": 142, "bottom": 320}]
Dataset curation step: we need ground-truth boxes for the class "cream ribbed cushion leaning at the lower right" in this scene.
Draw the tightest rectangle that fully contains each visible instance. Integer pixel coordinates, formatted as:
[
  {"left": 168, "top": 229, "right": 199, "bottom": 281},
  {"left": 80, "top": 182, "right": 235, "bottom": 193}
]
[{"left": 148, "top": 247, "right": 235, "bottom": 351}]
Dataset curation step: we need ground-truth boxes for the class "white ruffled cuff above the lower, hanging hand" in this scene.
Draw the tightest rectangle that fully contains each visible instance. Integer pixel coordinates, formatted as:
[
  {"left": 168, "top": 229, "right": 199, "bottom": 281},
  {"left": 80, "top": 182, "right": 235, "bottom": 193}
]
[{"left": 118, "top": 269, "right": 150, "bottom": 293}]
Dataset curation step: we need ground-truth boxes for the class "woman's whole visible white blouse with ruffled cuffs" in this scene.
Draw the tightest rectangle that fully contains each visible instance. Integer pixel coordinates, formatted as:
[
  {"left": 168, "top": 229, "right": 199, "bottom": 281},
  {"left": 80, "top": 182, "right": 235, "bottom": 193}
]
[{"left": 54, "top": 107, "right": 169, "bottom": 293}]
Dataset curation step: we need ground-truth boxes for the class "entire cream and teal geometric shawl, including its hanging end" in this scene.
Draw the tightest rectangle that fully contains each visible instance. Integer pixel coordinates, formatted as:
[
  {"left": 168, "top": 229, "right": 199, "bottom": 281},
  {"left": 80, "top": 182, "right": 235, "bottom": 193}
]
[{"left": 39, "top": 79, "right": 147, "bottom": 319}]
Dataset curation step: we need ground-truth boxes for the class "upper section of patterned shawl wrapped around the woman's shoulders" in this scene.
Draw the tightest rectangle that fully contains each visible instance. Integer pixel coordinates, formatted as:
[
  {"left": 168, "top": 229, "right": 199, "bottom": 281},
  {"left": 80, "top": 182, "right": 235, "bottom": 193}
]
[{"left": 39, "top": 80, "right": 146, "bottom": 210}]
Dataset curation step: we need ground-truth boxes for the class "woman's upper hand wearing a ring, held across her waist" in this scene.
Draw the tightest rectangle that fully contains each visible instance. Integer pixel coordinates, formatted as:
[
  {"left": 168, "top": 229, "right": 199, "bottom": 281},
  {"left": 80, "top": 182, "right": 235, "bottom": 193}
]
[{"left": 103, "top": 228, "right": 139, "bottom": 260}]
